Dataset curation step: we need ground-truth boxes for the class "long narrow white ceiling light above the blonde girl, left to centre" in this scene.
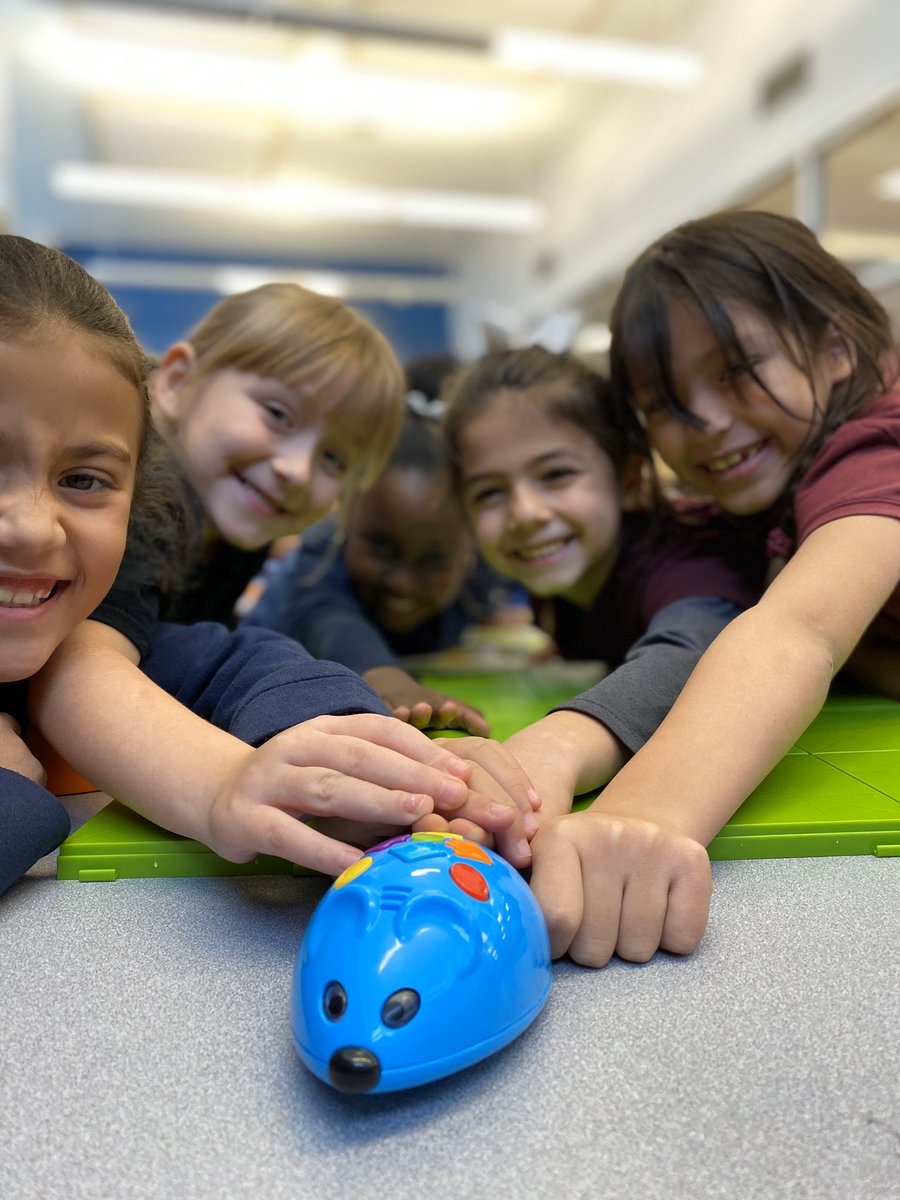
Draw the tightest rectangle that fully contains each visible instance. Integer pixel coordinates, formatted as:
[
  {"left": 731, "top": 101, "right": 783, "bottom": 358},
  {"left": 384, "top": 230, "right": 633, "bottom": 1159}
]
[{"left": 49, "top": 162, "right": 544, "bottom": 233}]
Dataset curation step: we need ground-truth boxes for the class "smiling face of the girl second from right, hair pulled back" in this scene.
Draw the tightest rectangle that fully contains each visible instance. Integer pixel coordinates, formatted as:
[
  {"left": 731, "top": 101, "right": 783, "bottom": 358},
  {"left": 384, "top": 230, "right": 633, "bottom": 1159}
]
[{"left": 458, "top": 391, "right": 622, "bottom": 607}]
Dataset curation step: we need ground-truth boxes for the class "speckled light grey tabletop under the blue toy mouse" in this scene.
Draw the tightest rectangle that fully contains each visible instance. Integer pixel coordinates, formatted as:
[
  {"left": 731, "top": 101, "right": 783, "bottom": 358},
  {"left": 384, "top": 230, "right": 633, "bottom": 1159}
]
[{"left": 0, "top": 858, "right": 900, "bottom": 1200}]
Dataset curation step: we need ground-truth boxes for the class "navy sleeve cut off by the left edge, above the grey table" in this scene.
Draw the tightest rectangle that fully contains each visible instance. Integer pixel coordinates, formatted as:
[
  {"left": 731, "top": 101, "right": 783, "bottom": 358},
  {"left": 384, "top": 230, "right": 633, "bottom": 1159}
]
[{"left": 0, "top": 767, "right": 72, "bottom": 893}]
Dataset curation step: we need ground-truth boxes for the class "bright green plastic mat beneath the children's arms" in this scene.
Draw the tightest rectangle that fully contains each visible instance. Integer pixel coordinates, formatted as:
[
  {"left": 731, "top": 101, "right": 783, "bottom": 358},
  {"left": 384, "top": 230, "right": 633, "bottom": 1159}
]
[{"left": 58, "top": 664, "right": 900, "bottom": 882}]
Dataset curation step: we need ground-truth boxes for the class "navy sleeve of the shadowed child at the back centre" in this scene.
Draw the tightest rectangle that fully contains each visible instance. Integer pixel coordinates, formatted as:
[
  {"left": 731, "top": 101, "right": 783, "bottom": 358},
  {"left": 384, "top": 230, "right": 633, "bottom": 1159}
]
[{"left": 242, "top": 538, "right": 402, "bottom": 674}]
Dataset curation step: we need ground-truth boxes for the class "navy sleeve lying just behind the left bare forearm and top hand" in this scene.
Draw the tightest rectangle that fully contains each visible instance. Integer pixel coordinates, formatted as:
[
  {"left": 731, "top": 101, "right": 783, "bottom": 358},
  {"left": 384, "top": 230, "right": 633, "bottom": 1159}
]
[{"left": 142, "top": 622, "right": 390, "bottom": 745}]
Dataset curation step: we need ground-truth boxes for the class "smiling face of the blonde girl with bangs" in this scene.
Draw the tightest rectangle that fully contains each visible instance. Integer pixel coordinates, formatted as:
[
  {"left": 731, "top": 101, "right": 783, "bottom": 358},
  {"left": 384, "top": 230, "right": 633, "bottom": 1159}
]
[{"left": 154, "top": 350, "right": 365, "bottom": 550}]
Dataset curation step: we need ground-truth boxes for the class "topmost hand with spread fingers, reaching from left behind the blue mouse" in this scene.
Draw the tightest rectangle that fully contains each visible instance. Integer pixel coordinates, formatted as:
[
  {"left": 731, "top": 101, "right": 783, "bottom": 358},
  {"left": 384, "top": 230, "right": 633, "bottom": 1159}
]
[{"left": 200, "top": 714, "right": 530, "bottom": 875}]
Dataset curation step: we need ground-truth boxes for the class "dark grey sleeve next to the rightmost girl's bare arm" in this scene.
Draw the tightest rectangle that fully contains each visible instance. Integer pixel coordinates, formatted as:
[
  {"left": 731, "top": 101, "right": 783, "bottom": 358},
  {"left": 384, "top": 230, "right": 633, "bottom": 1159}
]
[{"left": 554, "top": 596, "right": 743, "bottom": 752}]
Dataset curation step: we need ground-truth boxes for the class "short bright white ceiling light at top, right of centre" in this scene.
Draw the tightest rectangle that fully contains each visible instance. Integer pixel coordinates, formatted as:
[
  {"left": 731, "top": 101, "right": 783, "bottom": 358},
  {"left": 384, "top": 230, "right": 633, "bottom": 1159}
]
[{"left": 491, "top": 29, "right": 703, "bottom": 88}]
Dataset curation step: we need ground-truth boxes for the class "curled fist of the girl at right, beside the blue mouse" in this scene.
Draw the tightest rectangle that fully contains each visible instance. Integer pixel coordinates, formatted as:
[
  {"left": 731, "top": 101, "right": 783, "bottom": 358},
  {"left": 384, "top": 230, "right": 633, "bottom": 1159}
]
[{"left": 532, "top": 808, "right": 713, "bottom": 967}]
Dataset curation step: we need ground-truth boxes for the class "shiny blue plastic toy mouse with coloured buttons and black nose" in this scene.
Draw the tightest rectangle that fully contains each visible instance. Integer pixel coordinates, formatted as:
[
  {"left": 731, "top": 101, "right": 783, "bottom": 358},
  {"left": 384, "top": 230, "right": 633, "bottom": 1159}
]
[{"left": 292, "top": 833, "right": 551, "bottom": 1092}]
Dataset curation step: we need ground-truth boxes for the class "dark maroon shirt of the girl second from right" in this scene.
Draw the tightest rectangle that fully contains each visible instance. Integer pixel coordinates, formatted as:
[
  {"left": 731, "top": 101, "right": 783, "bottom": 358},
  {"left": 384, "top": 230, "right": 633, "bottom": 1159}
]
[{"left": 533, "top": 512, "right": 766, "bottom": 667}]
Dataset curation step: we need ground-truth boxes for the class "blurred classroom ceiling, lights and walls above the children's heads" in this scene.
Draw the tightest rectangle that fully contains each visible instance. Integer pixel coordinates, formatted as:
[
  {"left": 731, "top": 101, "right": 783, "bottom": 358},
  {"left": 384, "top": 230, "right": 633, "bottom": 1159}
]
[{"left": 0, "top": 0, "right": 900, "bottom": 365}]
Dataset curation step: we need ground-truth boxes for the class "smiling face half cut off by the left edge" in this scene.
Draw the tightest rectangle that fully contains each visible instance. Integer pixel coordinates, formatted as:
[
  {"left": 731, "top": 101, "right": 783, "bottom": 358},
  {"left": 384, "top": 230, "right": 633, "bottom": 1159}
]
[{"left": 0, "top": 326, "right": 143, "bottom": 682}]
